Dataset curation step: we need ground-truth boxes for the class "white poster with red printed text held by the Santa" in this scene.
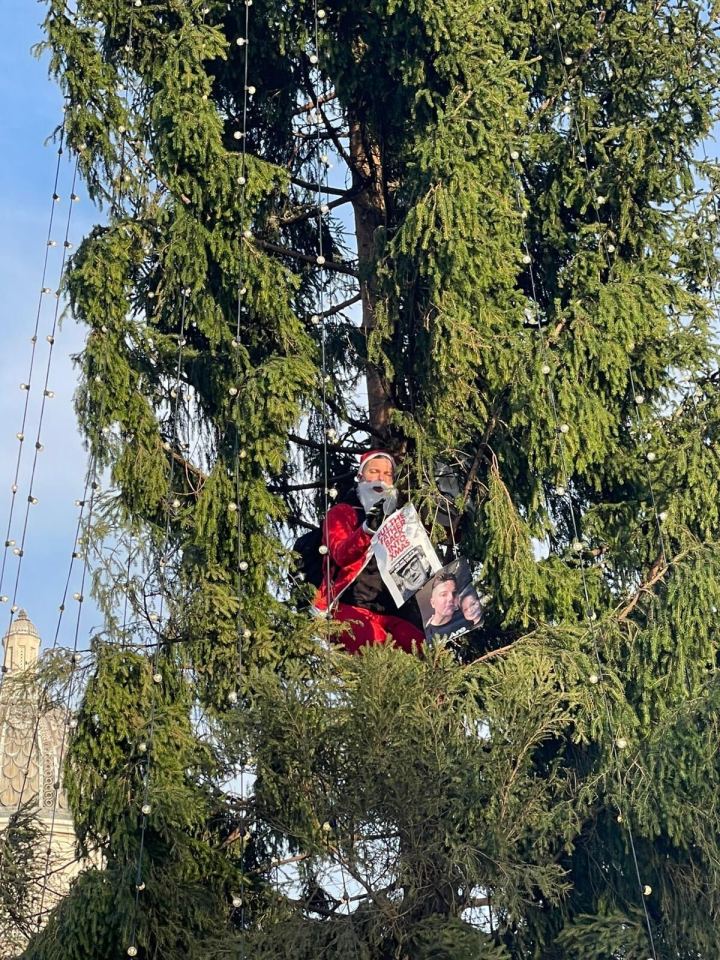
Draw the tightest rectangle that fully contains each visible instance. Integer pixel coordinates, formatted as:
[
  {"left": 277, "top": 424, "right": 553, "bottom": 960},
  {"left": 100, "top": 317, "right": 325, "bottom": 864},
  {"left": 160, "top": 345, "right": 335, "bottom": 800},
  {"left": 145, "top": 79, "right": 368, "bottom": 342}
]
[{"left": 370, "top": 503, "right": 442, "bottom": 607}]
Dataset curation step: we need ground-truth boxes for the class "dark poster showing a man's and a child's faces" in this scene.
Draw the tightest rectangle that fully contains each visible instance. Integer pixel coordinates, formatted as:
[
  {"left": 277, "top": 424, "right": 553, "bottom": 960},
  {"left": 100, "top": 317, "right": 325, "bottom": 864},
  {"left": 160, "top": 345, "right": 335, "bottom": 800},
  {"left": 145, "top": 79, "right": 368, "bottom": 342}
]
[{"left": 417, "top": 560, "right": 483, "bottom": 640}]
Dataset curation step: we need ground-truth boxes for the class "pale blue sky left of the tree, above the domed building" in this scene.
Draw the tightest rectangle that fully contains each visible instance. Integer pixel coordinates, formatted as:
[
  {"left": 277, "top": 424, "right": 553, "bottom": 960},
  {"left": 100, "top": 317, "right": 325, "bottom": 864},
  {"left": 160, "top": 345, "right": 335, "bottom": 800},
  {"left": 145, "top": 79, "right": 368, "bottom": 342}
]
[{"left": 0, "top": 0, "right": 98, "bottom": 646}]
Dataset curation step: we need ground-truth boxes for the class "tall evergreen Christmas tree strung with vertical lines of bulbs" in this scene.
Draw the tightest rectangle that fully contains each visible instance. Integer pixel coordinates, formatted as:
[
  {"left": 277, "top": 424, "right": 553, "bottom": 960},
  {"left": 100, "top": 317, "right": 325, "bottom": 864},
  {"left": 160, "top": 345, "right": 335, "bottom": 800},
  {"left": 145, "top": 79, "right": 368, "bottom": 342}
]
[{"left": 18, "top": 0, "right": 720, "bottom": 960}]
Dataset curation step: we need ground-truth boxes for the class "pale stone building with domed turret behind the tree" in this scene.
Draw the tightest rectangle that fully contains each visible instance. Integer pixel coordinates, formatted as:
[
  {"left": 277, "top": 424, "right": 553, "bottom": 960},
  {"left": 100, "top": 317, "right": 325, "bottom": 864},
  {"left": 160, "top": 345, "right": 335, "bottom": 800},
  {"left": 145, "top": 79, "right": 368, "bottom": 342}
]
[{"left": 0, "top": 610, "right": 80, "bottom": 960}]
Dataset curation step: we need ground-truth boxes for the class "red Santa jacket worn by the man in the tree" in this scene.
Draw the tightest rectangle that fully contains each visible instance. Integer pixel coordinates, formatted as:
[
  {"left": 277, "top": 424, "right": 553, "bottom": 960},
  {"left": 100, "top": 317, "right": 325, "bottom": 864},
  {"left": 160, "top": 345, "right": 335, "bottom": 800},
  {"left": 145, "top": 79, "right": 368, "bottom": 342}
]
[{"left": 313, "top": 503, "right": 372, "bottom": 612}]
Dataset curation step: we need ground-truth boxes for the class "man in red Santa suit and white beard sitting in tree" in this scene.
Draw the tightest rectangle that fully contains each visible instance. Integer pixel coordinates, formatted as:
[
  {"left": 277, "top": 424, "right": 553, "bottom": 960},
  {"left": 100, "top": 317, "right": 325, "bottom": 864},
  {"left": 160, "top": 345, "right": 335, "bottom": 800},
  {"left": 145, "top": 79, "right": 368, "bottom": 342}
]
[{"left": 314, "top": 450, "right": 423, "bottom": 653}]
